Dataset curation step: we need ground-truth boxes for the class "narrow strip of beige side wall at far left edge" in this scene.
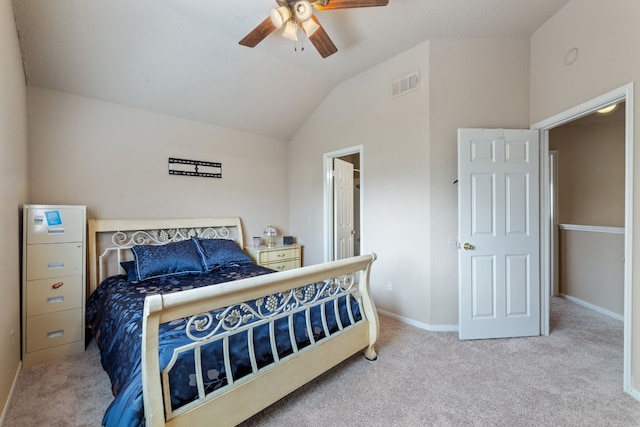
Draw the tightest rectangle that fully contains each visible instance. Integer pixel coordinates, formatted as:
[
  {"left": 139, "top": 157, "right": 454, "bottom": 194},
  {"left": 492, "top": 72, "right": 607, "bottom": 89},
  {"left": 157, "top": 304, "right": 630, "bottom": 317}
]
[{"left": 0, "top": 0, "right": 27, "bottom": 418}]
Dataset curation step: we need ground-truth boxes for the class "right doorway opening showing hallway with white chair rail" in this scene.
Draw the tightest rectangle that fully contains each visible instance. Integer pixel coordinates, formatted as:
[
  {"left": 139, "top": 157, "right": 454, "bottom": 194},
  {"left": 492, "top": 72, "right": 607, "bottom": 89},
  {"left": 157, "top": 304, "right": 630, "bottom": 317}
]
[{"left": 549, "top": 102, "right": 626, "bottom": 320}]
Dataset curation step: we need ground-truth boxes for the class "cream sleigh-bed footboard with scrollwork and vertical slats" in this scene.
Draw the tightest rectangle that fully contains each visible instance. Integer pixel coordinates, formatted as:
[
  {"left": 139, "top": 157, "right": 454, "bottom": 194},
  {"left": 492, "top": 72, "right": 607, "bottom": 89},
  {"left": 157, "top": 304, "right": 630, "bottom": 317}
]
[{"left": 142, "top": 254, "right": 378, "bottom": 427}]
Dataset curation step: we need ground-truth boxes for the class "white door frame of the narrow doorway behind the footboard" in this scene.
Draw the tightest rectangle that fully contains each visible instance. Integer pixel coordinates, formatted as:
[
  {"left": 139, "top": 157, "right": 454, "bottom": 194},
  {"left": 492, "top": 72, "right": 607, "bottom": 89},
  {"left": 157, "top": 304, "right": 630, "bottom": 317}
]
[{"left": 322, "top": 144, "right": 364, "bottom": 262}]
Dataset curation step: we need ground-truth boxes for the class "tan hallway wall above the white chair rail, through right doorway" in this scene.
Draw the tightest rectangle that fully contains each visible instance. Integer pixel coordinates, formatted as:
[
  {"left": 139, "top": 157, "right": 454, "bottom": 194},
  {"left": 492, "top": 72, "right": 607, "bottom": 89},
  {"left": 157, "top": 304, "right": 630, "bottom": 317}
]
[{"left": 549, "top": 121, "right": 625, "bottom": 227}]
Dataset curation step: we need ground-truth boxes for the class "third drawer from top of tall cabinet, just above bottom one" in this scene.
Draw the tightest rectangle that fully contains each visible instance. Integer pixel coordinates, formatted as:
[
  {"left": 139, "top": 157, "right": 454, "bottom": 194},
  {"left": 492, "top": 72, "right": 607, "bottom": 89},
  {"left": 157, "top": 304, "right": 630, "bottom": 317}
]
[{"left": 27, "top": 276, "right": 82, "bottom": 316}]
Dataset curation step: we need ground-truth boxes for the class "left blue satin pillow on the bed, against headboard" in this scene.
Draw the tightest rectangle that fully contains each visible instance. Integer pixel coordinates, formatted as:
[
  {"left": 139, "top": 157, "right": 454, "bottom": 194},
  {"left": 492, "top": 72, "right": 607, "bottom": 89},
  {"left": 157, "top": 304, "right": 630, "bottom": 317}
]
[{"left": 131, "top": 239, "right": 204, "bottom": 281}]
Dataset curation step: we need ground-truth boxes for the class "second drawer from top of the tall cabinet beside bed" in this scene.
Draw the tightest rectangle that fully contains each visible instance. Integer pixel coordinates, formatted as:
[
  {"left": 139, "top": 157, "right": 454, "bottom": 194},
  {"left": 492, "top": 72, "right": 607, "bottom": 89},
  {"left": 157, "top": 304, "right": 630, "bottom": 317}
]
[{"left": 26, "top": 243, "right": 84, "bottom": 280}]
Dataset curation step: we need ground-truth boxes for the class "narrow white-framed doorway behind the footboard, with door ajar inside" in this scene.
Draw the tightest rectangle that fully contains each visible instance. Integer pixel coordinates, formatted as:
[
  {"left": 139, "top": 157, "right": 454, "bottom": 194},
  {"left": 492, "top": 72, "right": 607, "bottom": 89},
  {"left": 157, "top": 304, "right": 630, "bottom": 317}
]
[{"left": 324, "top": 145, "right": 364, "bottom": 262}]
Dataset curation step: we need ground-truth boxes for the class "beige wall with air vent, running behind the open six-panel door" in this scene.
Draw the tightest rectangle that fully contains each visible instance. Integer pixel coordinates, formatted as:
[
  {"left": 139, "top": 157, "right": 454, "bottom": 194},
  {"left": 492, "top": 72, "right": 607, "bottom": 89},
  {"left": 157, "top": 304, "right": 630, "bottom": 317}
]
[{"left": 290, "top": 39, "right": 529, "bottom": 329}]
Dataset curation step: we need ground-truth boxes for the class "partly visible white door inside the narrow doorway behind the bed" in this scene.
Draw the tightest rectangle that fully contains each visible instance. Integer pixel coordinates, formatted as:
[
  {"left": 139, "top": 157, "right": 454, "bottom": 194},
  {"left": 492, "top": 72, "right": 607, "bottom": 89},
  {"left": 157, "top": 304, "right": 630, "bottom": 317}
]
[{"left": 333, "top": 159, "right": 355, "bottom": 259}]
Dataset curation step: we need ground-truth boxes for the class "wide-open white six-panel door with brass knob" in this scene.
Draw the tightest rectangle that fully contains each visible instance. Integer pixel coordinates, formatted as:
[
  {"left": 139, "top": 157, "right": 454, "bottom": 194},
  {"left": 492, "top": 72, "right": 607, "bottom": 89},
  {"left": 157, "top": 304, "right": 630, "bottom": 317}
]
[{"left": 458, "top": 129, "right": 541, "bottom": 339}]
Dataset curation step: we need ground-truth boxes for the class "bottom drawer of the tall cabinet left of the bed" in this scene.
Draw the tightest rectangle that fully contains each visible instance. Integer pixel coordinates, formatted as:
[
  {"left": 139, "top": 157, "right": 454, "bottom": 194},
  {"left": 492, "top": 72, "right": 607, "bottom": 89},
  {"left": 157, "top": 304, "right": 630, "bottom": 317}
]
[{"left": 27, "top": 308, "right": 82, "bottom": 352}]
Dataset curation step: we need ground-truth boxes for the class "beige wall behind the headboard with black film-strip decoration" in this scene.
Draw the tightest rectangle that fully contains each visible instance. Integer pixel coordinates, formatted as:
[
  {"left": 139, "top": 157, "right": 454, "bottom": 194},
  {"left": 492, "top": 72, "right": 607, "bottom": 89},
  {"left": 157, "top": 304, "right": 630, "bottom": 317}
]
[{"left": 27, "top": 87, "right": 289, "bottom": 242}]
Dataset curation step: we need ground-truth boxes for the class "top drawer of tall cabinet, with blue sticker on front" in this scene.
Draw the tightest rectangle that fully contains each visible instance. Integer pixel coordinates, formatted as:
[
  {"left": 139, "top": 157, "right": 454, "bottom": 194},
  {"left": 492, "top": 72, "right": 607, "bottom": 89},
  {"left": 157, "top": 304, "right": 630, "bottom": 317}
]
[{"left": 24, "top": 207, "right": 85, "bottom": 244}]
